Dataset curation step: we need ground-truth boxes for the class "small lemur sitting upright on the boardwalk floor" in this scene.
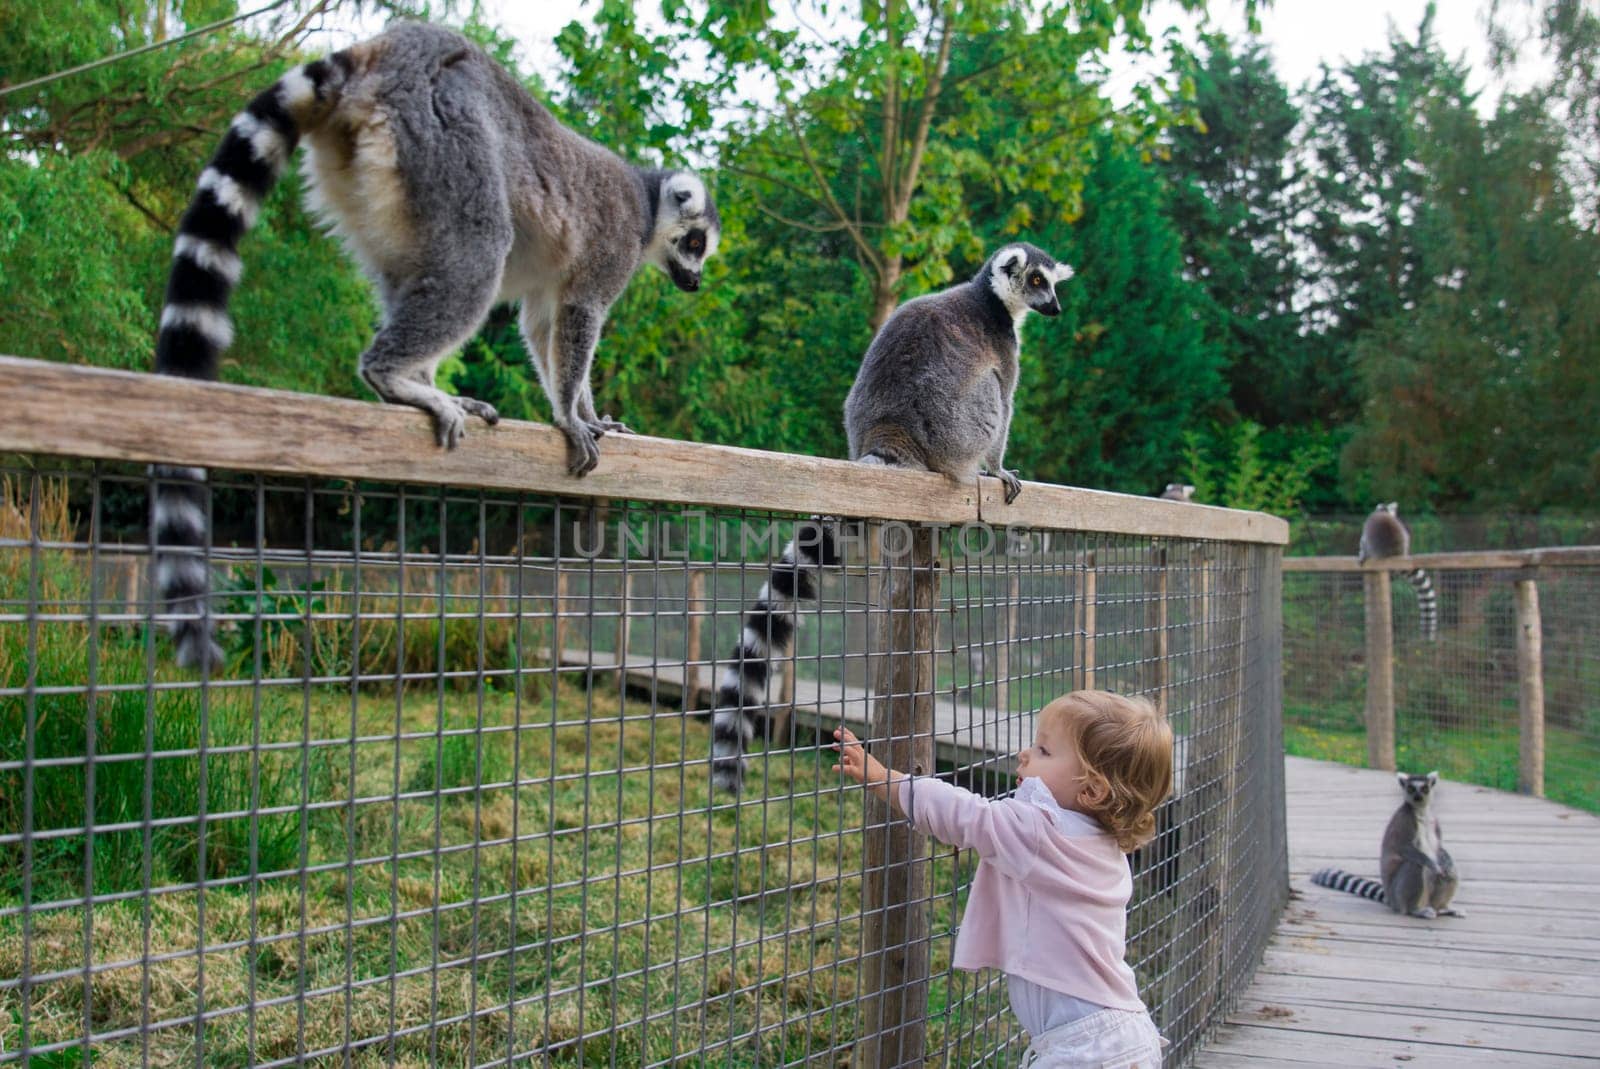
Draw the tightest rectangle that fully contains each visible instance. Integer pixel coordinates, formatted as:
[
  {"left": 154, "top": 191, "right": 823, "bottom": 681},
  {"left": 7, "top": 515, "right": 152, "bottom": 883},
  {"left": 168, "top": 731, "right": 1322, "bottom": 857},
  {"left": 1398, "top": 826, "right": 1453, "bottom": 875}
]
[{"left": 1310, "top": 771, "right": 1466, "bottom": 917}]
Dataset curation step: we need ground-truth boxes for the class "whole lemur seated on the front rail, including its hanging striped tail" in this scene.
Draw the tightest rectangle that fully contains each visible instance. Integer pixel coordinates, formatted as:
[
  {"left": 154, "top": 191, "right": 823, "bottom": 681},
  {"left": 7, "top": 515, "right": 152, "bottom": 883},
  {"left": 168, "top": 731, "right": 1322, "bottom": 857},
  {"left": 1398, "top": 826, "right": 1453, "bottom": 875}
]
[{"left": 712, "top": 242, "right": 1072, "bottom": 791}]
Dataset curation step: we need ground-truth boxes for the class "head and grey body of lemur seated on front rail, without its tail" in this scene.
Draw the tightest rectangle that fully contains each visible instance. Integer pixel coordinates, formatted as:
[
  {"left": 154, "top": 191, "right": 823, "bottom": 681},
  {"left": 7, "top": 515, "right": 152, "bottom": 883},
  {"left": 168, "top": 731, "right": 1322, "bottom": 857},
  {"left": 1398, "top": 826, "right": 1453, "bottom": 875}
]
[{"left": 845, "top": 243, "right": 1072, "bottom": 502}]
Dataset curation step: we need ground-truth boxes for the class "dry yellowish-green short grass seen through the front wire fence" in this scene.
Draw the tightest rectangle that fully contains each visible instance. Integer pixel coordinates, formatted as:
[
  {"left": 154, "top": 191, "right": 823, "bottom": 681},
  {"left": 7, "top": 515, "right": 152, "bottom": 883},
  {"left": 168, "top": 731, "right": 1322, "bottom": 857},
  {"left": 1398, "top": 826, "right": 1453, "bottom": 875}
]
[{"left": 0, "top": 688, "right": 1011, "bottom": 1066}]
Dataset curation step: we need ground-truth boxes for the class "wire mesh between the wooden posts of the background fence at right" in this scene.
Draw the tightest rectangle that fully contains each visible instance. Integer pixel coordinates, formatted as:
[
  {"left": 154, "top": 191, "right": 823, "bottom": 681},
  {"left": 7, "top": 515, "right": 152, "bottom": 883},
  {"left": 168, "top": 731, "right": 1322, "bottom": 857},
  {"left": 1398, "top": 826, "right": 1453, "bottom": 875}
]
[{"left": 1283, "top": 567, "right": 1600, "bottom": 810}]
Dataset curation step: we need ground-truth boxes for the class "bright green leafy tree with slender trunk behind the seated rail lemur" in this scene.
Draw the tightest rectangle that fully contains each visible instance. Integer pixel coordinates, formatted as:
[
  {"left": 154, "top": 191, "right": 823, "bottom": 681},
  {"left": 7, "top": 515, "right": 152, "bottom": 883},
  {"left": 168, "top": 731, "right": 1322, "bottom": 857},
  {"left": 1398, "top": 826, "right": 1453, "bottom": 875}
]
[{"left": 698, "top": 0, "right": 1228, "bottom": 328}]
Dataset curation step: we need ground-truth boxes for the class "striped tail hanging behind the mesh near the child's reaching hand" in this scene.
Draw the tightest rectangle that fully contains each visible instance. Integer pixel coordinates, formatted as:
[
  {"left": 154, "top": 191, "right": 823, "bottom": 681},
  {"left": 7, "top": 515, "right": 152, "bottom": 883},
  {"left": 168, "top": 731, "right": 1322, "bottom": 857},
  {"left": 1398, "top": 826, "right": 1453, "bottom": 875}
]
[{"left": 710, "top": 518, "right": 838, "bottom": 794}]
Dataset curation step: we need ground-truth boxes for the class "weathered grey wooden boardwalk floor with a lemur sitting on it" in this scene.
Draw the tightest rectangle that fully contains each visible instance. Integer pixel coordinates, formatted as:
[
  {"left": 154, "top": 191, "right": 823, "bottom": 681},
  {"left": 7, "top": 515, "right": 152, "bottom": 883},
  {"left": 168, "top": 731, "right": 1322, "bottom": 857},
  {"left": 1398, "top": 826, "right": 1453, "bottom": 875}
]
[{"left": 1192, "top": 757, "right": 1600, "bottom": 1069}]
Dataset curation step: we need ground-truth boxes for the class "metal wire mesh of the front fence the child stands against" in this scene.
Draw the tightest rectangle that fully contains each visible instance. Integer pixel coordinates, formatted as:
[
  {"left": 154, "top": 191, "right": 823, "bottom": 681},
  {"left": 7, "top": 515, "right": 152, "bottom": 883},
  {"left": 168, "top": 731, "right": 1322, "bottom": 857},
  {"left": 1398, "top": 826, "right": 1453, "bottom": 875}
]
[{"left": 0, "top": 458, "right": 1286, "bottom": 1066}]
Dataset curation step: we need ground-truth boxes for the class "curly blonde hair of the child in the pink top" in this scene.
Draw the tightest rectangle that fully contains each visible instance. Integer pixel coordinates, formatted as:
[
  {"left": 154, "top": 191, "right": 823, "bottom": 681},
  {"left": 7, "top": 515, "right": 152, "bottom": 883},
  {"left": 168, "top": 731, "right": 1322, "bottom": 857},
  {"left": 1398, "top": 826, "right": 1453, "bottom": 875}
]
[{"left": 1038, "top": 690, "right": 1173, "bottom": 853}]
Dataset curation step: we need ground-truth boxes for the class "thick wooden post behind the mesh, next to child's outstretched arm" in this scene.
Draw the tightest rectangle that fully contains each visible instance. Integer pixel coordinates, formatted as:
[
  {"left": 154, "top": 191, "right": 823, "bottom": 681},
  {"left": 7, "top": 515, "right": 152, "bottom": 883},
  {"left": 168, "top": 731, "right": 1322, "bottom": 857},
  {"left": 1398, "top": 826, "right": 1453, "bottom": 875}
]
[{"left": 853, "top": 525, "right": 939, "bottom": 1069}]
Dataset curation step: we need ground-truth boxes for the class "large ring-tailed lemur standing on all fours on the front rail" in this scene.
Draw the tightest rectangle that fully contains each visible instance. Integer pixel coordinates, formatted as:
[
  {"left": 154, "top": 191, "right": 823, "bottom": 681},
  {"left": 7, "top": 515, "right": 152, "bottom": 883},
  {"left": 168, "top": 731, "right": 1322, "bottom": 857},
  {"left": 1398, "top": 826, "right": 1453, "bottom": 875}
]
[{"left": 154, "top": 22, "right": 722, "bottom": 664}]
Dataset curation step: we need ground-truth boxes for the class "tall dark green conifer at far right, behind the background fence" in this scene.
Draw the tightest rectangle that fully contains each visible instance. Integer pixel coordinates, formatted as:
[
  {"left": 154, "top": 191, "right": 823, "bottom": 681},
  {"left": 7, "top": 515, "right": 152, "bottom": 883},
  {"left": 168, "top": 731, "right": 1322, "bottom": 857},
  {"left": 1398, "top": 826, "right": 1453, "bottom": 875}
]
[{"left": 1344, "top": 94, "right": 1600, "bottom": 509}]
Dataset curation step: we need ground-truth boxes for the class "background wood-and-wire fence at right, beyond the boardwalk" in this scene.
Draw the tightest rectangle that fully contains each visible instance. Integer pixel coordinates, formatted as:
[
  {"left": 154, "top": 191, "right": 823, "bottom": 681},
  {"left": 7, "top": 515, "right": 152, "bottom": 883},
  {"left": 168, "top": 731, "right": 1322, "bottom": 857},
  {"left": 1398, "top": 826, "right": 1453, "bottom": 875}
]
[{"left": 1283, "top": 546, "right": 1600, "bottom": 810}]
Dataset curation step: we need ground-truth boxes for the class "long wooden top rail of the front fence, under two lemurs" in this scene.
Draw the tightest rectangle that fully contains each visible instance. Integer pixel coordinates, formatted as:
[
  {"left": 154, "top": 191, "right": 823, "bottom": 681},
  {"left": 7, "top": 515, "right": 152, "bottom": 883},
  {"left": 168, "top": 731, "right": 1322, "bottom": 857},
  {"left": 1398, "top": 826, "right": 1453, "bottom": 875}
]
[{"left": 0, "top": 357, "right": 1288, "bottom": 546}]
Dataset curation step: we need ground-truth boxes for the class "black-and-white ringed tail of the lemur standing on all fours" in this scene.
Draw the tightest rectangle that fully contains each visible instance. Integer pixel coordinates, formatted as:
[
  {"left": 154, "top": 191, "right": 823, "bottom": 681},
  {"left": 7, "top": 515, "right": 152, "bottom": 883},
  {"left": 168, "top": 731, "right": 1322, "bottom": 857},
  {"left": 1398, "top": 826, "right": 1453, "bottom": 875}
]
[{"left": 150, "top": 53, "right": 352, "bottom": 667}]
